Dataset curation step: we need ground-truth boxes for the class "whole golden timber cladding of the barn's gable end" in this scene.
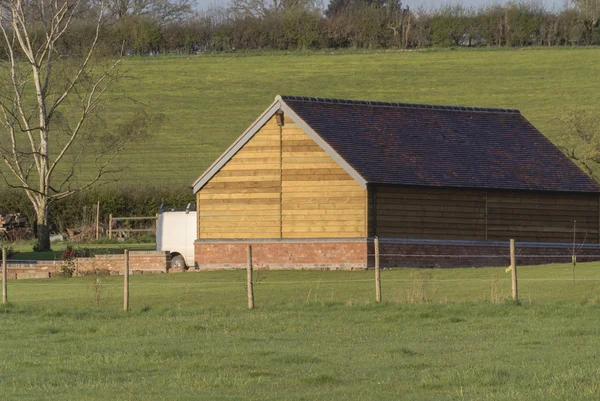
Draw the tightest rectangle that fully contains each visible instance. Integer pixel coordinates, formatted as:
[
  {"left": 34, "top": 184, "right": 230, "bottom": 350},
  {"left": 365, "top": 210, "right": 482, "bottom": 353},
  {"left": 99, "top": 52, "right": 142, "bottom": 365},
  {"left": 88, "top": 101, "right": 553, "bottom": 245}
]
[{"left": 196, "top": 116, "right": 366, "bottom": 239}]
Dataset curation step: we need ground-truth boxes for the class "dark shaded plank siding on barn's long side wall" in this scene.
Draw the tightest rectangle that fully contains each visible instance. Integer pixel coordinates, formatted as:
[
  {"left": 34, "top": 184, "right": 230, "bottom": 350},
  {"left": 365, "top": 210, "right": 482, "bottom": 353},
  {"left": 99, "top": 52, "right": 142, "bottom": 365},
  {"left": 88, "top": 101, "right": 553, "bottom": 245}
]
[{"left": 370, "top": 187, "right": 600, "bottom": 243}]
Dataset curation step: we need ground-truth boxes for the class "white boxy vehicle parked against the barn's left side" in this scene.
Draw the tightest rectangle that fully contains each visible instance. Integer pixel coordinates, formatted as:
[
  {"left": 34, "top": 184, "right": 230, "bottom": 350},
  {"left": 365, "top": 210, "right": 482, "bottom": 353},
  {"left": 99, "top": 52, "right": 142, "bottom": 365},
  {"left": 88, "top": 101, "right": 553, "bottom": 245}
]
[{"left": 156, "top": 205, "right": 196, "bottom": 269}]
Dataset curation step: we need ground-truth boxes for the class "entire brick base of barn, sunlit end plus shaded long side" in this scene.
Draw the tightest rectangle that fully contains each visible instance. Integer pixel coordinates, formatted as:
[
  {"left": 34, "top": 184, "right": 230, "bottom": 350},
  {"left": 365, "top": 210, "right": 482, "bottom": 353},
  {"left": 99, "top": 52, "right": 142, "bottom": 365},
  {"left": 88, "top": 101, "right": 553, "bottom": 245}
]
[{"left": 195, "top": 238, "right": 600, "bottom": 270}]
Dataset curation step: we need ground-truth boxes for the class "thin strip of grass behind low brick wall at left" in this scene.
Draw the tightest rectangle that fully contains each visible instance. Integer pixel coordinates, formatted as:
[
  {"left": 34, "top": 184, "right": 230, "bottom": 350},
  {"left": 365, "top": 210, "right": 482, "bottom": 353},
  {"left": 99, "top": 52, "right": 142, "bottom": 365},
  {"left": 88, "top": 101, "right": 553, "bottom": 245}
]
[{"left": 9, "top": 241, "right": 156, "bottom": 260}]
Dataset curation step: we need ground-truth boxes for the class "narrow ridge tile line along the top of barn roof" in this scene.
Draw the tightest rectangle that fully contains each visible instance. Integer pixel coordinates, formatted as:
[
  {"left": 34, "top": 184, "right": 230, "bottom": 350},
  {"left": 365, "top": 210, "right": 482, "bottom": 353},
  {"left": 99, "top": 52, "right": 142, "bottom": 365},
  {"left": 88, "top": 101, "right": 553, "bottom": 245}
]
[{"left": 280, "top": 95, "right": 521, "bottom": 114}]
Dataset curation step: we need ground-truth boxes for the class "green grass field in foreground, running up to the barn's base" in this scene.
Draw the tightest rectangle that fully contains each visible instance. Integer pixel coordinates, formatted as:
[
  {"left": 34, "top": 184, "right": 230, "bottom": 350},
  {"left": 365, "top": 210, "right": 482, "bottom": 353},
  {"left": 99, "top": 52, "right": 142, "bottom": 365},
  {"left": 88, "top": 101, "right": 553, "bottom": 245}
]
[{"left": 0, "top": 263, "right": 600, "bottom": 400}]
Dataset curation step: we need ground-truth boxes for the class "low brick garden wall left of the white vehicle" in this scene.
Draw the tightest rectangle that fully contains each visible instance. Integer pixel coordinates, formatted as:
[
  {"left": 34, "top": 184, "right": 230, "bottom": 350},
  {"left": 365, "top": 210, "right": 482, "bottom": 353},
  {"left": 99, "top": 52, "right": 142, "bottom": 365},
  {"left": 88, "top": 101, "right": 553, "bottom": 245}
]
[{"left": 0, "top": 251, "right": 171, "bottom": 280}]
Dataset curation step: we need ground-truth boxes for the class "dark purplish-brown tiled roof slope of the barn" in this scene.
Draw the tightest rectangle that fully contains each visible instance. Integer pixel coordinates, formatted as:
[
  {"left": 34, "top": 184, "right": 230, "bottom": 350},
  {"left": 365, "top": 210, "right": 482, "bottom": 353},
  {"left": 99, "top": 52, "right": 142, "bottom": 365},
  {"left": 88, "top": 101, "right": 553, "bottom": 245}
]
[{"left": 281, "top": 96, "right": 600, "bottom": 192}]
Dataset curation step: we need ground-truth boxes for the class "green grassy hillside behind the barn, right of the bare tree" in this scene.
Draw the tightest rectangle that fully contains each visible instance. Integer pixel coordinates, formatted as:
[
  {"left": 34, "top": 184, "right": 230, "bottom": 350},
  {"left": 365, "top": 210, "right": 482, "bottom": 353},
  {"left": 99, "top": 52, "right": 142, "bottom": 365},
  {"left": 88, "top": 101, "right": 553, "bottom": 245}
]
[{"left": 90, "top": 48, "right": 600, "bottom": 185}]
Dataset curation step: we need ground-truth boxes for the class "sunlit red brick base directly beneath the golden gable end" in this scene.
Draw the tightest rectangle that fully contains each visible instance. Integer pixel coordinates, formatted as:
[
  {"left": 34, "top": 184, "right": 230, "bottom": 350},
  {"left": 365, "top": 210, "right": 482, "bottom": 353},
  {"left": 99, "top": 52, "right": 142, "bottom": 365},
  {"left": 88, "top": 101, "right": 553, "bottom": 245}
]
[{"left": 194, "top": 238, "right": 367, "bottom": 271}]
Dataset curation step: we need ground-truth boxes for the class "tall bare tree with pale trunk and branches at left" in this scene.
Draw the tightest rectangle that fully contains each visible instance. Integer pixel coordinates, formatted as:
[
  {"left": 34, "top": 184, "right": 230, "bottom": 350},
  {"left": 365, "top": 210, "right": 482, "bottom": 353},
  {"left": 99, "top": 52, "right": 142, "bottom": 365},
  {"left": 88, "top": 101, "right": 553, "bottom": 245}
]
[{"left": 0, "top": 0, "right": 154, "bottom": 251}]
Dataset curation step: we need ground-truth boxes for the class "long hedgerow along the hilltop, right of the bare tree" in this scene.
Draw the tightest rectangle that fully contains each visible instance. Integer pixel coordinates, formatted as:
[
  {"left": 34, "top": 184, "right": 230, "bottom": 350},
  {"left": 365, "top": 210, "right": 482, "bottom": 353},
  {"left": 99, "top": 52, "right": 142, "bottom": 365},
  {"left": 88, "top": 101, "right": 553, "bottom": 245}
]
[{"left": 31, "top": 0, "right": 600, "bottom": 55}]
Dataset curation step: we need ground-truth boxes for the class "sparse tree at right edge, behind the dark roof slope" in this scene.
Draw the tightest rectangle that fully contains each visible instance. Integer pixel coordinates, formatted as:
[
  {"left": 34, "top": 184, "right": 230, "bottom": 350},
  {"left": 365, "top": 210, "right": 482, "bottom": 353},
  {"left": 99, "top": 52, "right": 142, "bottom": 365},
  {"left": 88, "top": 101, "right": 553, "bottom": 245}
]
[{"left": 559, "top": 109, "right": 600, "bottom": 182}]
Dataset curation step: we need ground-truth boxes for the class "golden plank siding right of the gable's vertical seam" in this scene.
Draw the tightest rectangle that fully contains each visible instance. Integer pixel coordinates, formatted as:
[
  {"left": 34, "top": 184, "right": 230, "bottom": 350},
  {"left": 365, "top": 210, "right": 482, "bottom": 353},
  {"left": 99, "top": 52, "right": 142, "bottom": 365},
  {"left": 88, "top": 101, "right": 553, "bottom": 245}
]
[{"left": 281, "top": 118, "right": 367, "bottom": 238}]
